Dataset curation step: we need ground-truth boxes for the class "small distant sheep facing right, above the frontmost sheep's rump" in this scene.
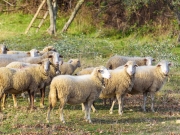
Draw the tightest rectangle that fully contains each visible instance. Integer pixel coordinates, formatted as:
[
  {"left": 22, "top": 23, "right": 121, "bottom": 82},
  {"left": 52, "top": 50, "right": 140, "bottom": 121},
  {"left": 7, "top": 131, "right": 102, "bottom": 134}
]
[{"left": 59, "top": 59, "right": 81, "bottom": 75}]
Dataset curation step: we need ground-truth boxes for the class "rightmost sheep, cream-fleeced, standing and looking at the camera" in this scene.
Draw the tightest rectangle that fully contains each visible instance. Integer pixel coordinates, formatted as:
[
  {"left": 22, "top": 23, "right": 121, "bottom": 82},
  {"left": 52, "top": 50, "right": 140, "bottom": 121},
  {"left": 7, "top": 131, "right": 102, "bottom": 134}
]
[{"left": 111, "top": 60, "right": 171, "bottom": 112}]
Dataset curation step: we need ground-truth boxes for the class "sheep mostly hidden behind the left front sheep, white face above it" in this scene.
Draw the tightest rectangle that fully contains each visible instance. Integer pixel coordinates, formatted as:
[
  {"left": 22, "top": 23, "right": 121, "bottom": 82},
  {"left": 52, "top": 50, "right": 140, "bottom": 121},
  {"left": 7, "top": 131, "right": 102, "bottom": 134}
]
[{"left": 2, "top": 52, "right": 62, "bottom": 109}]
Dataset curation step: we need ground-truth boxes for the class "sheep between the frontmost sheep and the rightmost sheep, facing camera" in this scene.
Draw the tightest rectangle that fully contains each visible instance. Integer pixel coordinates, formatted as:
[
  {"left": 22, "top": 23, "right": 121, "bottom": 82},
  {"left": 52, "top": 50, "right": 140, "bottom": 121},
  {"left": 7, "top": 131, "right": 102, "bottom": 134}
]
[{"left": 82, "top": 61, "right": 137, "bottom": 115}]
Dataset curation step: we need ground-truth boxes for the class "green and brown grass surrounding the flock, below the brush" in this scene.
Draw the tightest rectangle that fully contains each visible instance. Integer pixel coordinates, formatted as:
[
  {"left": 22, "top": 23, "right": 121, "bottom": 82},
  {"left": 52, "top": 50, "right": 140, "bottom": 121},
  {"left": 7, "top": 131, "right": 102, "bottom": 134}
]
[{"left": 0, "top": 14, "right": 180, "bottom": 135}]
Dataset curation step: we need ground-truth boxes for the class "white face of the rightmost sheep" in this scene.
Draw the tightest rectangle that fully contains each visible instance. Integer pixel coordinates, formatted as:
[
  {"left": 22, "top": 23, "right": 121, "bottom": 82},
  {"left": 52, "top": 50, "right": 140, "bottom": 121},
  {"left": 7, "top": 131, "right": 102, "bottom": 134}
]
[{"left": 157, "top": 61, "right": 171, "bottom": 76}]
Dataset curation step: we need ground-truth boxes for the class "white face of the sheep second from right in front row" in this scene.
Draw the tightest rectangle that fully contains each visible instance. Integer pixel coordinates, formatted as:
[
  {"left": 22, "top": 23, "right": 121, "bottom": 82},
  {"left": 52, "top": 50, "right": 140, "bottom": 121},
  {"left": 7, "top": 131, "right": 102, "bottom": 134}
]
[{"left": 124, "top": 61, "right": 137, "bottom": 76}]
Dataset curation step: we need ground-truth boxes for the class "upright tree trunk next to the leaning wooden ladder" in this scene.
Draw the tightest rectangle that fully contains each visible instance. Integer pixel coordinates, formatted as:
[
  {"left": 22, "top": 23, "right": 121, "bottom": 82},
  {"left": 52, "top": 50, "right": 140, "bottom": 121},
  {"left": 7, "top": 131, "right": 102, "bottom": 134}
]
[{"left": 47, "top": 0, "right": 57, "bottom": 35}]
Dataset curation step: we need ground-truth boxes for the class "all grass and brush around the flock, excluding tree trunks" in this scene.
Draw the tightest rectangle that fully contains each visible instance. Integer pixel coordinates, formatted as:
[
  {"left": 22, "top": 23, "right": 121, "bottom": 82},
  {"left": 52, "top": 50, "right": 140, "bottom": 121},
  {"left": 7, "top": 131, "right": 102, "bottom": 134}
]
[{"left": 0, "top": 0, "right": 180, "bottom": 135}]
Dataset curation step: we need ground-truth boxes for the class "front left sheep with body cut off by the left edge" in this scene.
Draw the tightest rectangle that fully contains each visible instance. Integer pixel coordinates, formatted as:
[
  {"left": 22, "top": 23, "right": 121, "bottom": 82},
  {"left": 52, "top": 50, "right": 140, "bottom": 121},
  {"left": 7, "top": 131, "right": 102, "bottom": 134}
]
[{"left": 0, "top": 59, "right": 51, "bottom": 112}]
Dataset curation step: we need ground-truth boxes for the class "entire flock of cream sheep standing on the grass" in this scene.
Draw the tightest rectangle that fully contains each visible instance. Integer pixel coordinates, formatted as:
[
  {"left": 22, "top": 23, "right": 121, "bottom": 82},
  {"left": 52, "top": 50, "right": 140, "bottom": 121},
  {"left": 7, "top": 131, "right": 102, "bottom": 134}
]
[{"left": 0, "top": 45, "right": 171, "bottom": 123}]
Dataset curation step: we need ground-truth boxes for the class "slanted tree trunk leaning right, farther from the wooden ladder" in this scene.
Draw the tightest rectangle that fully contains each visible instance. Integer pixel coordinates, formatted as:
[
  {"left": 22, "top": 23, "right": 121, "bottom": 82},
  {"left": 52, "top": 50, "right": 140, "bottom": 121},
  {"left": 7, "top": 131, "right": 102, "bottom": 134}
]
[{"left": 61, "top": 0, "right": 84, "bottom": 33}]
